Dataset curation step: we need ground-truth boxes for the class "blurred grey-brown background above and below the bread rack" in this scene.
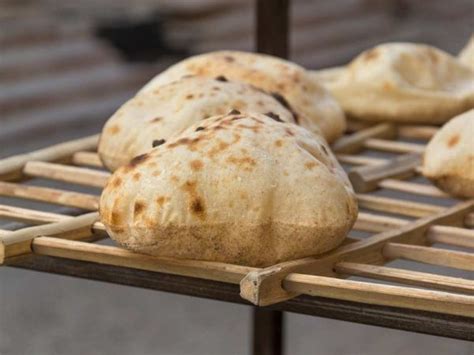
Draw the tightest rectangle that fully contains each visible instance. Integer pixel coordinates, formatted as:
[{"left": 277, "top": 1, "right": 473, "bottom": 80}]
[{"left": 0, "top": 0, "right": 474, "bottom": 355}]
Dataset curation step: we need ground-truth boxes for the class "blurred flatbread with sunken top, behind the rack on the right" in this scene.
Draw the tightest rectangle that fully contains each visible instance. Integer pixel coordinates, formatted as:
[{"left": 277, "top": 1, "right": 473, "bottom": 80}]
[{"left": 313, "top": 43, "right": 474, "bottom": 124}]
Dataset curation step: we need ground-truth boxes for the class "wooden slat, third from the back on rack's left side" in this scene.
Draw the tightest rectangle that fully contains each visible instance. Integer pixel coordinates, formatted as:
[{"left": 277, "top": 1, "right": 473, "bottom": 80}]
[{"left": 0, "top": 181, "right": 99, "bottom": 211}]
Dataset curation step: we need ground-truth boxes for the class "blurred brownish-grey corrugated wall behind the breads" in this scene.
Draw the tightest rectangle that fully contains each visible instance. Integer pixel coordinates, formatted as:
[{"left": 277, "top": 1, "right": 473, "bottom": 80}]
[{"left": 0, "top": 0, "right": 474, "bottom": 156}]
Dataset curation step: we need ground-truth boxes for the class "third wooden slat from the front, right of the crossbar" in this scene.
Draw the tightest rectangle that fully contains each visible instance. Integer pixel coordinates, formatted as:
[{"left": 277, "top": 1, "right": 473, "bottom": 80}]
[{"left": 383, "top": 243, "right": 474, "bottom": 271}]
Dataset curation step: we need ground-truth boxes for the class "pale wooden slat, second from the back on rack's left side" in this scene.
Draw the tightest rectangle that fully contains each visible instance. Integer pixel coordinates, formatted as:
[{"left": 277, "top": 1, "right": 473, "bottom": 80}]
[{"left": 23, "top": 161, "right": 110, "bottom": 187}]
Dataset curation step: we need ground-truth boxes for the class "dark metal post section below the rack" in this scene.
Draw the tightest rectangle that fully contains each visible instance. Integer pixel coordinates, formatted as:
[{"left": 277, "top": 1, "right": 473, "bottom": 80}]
[{"left": 253, "top": 307, "right": 283, "bottom": 355}]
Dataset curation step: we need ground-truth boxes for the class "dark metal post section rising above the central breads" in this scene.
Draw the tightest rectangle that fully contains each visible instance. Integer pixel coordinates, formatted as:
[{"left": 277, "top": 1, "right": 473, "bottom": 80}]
[{"left": 256, "top": 0, "right": 290, "bottom": 58}]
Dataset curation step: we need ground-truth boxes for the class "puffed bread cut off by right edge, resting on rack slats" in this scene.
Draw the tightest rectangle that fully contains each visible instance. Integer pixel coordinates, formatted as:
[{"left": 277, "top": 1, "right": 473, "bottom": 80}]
[{"left": 423, "top": 110, "right": 474, "bottom": 198}]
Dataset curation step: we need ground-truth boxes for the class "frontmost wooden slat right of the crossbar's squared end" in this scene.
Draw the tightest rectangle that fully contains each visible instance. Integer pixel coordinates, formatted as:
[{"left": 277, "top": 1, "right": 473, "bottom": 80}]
[{"left": 283, "top": 273, "right": 474, "bottom": 317}]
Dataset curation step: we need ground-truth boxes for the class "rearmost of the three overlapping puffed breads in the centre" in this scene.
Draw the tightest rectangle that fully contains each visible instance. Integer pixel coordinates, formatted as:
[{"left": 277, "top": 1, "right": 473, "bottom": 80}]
[{"left": 142, "top": 51, "right": 346, "bottom": 142}]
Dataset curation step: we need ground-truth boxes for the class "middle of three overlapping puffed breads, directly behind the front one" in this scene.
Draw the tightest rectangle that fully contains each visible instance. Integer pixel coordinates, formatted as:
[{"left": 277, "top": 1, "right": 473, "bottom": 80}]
[{"left": 98, "top": 77, "right": 294, "bottom": 170}]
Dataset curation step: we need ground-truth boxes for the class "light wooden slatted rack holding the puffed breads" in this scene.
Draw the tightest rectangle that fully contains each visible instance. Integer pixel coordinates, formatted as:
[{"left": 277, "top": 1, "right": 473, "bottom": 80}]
[{"left": 0, "top": 123, "right": 474, "bottom": 340}]
